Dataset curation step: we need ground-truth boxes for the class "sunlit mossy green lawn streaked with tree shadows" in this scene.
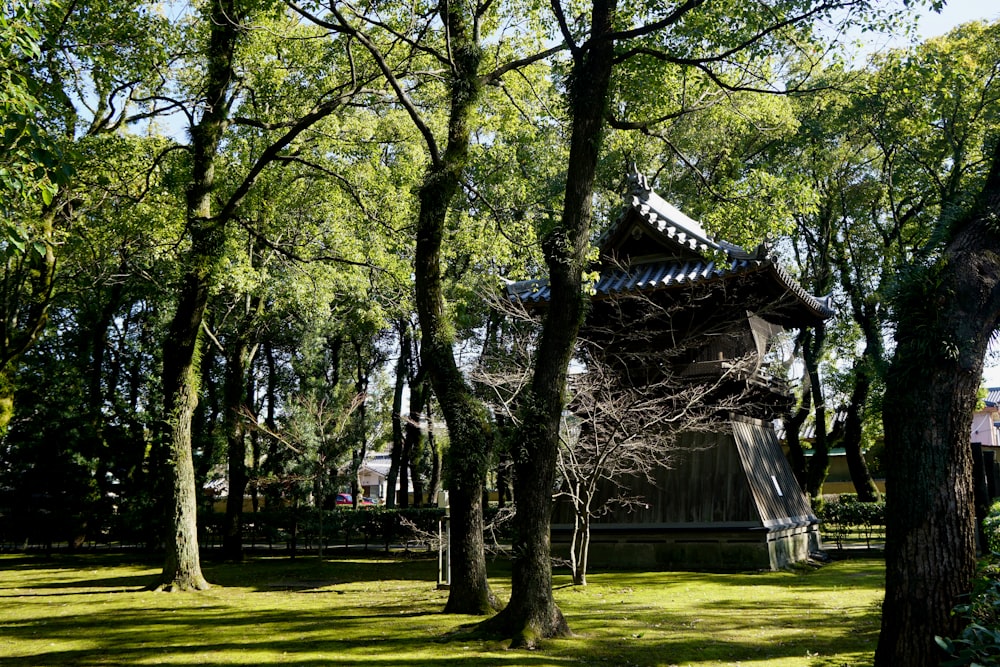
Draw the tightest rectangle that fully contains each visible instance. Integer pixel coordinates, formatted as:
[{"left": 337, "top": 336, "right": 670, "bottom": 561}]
[{"left": 0, "top": 555, "right": 883, "bottom": 667}]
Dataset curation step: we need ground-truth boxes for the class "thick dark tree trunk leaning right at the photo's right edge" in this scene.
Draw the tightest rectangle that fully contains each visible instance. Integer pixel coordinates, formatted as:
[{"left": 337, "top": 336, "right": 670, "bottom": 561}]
[{"left": 875, "top": 138, "right": 1000, "bottom": 667}]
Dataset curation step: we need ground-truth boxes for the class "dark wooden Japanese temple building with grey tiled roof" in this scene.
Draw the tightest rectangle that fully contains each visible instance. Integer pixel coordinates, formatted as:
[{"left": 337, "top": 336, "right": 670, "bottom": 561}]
[{"left": 508, "top": 174, "right": 833, "bottom": 570}]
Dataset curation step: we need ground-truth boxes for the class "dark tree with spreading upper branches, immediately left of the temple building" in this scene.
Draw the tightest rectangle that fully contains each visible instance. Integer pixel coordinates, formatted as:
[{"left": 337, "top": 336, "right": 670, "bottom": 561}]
[{"left": 483, "top": 0, "right": 900, "bottom": 646}]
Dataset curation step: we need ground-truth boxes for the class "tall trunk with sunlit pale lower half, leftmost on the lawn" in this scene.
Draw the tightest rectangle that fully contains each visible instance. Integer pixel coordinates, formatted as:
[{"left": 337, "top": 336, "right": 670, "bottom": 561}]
[{"left": 159, "top": 0, "right": 240, "bottom": 590}]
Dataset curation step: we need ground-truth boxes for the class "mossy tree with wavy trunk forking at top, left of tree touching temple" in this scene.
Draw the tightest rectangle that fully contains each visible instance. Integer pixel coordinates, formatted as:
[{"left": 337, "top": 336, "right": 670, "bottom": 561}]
[{"left": 290, "top": 1, "right": 556, "bottom": 614}]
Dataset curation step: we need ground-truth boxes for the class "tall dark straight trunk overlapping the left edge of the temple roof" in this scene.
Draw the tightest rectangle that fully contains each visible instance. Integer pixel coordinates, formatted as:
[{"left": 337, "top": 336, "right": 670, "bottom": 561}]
[{"left": 483, "top": 0, "right": 617, "bottom": 647}]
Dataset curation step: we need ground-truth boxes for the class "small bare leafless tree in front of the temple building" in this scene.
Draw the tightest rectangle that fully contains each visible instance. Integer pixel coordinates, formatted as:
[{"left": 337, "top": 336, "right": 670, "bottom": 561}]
[{"left": 555, "top": 350, "right": 754, "bottom": 586}]
